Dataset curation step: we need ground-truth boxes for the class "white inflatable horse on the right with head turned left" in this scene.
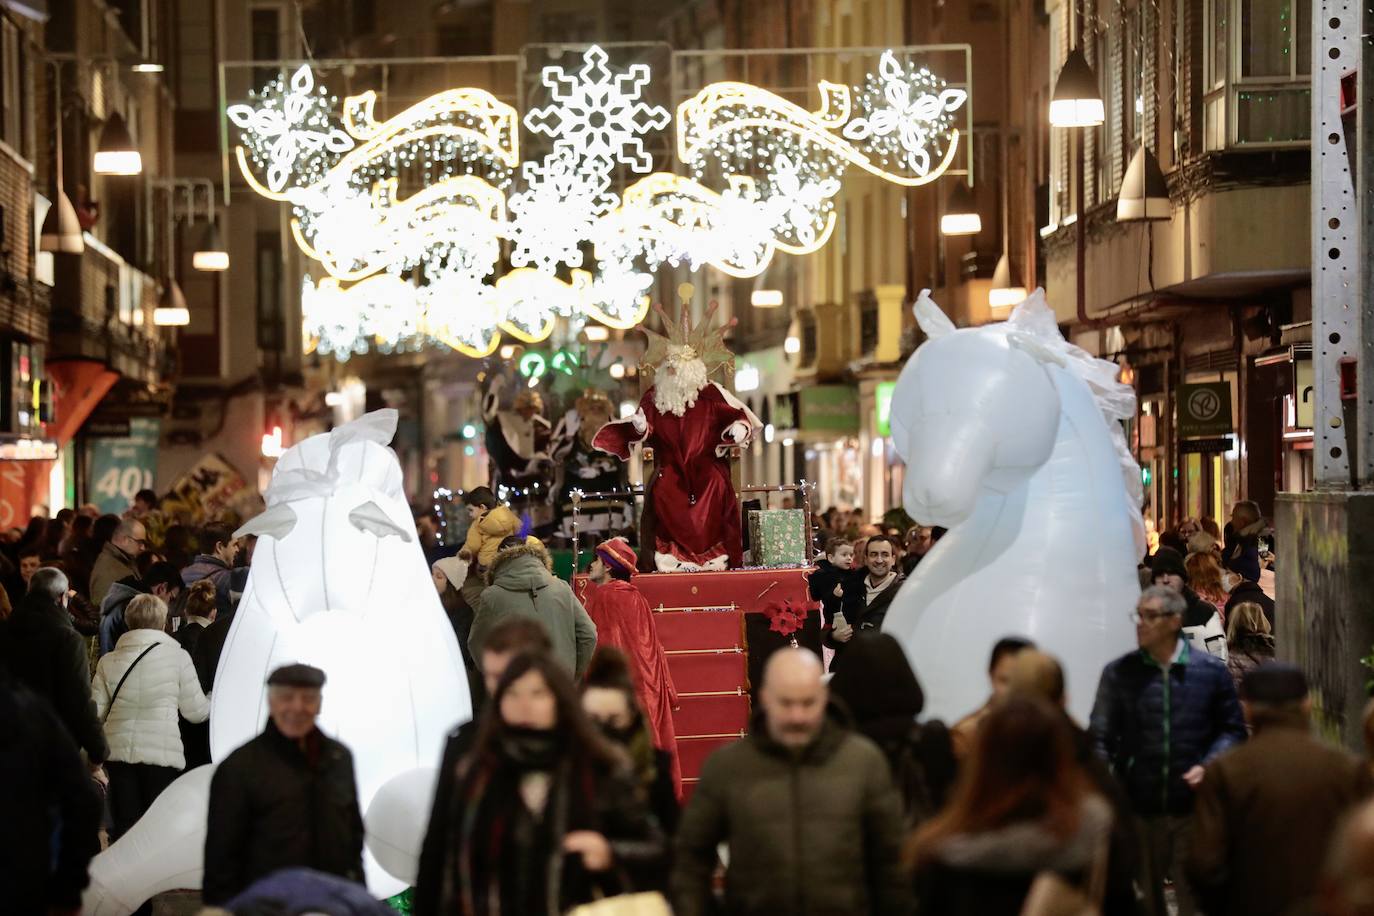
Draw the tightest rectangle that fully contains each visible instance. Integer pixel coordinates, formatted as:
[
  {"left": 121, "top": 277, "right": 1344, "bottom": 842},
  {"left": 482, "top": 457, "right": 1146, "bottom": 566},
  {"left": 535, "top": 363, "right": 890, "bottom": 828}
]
[{"left": 883, "top": 290, "right": 1145, "bottom": 721}]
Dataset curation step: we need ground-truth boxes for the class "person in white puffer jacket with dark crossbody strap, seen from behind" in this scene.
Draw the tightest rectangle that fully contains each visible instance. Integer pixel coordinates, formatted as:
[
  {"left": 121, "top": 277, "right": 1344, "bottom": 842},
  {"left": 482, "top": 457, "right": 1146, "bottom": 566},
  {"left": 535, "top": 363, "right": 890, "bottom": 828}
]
[{"left": 92, "top": 595, "right": 210, "bottom": 842}]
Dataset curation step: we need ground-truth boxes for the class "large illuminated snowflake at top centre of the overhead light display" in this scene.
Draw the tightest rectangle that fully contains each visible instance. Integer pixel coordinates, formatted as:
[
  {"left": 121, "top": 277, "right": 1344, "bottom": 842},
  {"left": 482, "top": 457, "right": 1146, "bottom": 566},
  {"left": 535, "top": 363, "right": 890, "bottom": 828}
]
[{"left": 525, "top": 47, "right": 672, "bottom": 174}]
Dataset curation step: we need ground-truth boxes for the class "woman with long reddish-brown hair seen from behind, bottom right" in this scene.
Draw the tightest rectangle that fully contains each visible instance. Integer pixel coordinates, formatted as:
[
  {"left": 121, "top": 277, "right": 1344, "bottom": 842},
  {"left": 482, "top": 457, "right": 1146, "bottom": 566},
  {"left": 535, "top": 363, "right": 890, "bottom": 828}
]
[{"left": 907, "top": 694, "right": 1112, "bottom": 916}]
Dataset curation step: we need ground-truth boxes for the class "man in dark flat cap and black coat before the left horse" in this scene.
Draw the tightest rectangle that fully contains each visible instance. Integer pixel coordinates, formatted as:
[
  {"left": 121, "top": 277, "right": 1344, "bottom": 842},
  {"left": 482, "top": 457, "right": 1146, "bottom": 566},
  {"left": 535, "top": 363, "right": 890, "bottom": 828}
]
[{"left": 202, "top": 665, "right": 363, "bottom": 905}]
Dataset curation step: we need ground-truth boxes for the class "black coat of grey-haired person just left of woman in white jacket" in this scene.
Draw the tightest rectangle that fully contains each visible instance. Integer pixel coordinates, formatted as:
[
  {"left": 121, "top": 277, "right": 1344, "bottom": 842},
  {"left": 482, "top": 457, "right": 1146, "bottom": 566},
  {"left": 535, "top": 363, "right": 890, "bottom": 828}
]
[{"left": 0, "top": 595, "right": 110, "bottom": 764}]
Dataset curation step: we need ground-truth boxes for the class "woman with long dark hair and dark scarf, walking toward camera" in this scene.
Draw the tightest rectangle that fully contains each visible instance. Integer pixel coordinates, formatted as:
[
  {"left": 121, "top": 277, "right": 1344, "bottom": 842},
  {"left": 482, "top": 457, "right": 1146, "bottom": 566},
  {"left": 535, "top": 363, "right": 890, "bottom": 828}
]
[{"left": 438, "top": 654, "right": 664, "bottom": 916}]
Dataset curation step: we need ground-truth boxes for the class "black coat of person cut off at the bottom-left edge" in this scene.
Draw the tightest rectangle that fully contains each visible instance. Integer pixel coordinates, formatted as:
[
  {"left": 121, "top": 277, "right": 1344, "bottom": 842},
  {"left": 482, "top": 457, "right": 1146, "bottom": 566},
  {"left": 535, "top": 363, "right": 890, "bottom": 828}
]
[{"left": 0, "top": 667, "right": 100, "bottom": 913}]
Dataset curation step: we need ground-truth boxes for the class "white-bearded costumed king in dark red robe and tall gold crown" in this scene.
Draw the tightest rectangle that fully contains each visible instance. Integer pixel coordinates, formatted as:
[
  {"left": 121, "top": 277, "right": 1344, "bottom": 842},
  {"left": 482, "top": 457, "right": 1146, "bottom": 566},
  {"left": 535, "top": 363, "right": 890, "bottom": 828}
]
[{"left": 594, "top": 302, "right": 763, "bottom": 571}]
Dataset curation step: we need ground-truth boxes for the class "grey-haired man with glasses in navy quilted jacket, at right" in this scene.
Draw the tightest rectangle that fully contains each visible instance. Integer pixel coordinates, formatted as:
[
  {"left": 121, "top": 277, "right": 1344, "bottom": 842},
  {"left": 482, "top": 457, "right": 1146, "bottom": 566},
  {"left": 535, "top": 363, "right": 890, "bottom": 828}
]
[{"left": 1090, "top": 585, "right": 1245, "bottom": 916}]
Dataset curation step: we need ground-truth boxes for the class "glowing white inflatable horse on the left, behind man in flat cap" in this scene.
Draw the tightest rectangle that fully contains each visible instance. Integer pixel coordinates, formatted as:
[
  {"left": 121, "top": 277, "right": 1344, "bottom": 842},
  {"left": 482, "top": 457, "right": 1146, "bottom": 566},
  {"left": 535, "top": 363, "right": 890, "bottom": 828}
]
[{"left": 84, "top": 411, "right": 471, "bottom": 916}]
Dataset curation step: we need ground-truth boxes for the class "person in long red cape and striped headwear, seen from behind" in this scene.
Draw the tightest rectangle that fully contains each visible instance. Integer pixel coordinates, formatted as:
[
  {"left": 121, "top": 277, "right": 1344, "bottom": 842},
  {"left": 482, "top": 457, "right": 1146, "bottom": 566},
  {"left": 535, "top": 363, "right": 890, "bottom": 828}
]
[{"left": 587, "top": 537, "right": 682, "bottom": 786}]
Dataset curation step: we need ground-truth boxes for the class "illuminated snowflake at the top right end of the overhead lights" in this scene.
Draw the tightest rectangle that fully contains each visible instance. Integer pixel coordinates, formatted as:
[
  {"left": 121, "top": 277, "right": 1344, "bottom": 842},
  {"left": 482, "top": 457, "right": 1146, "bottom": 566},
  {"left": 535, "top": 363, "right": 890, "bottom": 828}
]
[{"left": 844, "top": 51, "right": 969, "bottom": 176}]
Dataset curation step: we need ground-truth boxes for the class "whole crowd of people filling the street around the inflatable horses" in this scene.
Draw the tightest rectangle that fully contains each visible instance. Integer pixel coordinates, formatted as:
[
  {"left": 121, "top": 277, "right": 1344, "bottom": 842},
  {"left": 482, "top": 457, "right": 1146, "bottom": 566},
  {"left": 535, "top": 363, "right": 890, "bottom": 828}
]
[{"left": 8, "top": 488, "right": 1374, "bottom": 916}]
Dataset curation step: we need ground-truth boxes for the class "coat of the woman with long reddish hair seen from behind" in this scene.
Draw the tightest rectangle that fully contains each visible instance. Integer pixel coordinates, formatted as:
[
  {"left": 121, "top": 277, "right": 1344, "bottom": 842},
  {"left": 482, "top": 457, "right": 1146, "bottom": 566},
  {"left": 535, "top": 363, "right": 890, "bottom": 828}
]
[{"left": 915, "top": 795, "right": 1112, "bottom": 916}]
